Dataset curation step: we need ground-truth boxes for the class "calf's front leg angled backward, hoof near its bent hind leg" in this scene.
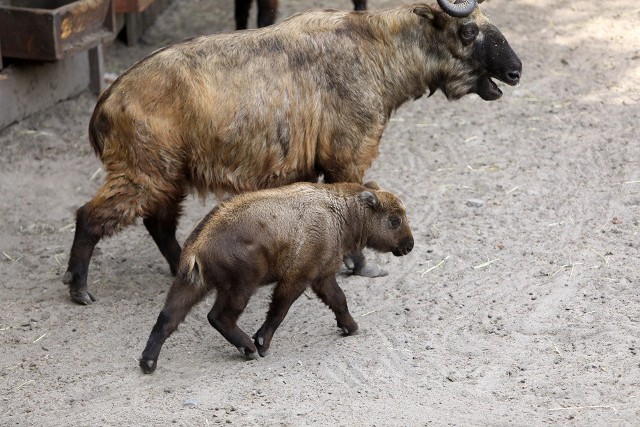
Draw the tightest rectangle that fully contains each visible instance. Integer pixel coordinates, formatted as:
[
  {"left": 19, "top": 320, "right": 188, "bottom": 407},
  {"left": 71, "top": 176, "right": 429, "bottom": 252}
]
[{"left": 253, "top": 282, "right": 305, "bottom": 357}]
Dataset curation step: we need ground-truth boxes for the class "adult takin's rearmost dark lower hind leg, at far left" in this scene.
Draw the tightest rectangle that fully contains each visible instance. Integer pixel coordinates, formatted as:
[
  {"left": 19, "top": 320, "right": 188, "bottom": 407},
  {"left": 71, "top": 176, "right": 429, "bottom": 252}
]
[{"left": 62, "top": 203, "right": 102, "bottom": 305}]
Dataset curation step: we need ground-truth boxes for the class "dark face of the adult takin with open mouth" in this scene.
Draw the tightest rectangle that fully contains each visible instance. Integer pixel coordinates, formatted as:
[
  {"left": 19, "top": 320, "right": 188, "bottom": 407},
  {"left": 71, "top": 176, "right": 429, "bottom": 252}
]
[{"left": 422, "top": 8, "right": 522, "bottom": 101}]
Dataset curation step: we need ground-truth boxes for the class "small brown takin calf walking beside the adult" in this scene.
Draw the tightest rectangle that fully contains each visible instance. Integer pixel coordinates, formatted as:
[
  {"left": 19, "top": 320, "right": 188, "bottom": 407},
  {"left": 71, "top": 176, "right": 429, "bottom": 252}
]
[{"left": 140, "top": 183, "right": 413, "bottom": 373}]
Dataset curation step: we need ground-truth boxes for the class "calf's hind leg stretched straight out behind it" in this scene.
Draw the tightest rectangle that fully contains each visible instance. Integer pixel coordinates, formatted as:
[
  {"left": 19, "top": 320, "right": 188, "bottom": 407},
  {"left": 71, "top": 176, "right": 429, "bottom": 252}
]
[{"left": 139, "top": 279, "right": 207, "bottom": 374}]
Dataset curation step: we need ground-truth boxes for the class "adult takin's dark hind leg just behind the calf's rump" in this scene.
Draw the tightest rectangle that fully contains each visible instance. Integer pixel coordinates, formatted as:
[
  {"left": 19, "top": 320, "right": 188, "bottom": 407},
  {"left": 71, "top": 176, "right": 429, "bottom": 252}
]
[{"left": 143, "top": 196, "right": 184, "bottom": 276}]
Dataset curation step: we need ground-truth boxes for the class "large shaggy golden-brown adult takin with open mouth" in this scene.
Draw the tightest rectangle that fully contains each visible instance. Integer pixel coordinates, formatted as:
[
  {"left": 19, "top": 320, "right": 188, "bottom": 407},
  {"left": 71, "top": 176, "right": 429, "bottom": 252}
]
[{"left": 63, "top": 0, "right": 522, "bottom": 304}]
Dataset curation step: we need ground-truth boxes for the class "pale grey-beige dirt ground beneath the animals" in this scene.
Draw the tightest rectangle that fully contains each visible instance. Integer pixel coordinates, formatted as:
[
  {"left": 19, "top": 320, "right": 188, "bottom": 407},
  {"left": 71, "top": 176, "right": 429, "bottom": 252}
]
[{"left": 0, "top": 0, "right": 640, "bottom": 426}]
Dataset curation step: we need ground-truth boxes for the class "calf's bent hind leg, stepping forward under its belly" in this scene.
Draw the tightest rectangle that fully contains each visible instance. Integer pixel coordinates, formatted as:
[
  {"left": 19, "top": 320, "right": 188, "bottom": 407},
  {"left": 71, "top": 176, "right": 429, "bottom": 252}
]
[{"left": 207, "top": 289, "right": 256, "bottom": 356}]
